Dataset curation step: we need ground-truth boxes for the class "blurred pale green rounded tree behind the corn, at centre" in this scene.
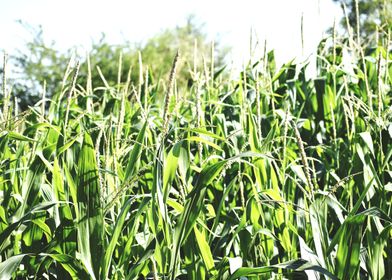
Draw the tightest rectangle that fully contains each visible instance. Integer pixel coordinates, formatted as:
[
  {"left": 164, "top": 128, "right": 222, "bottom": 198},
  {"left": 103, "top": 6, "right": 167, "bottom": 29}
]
[{"left": 85, "top": 16, "right": 228, "bottom": 89}]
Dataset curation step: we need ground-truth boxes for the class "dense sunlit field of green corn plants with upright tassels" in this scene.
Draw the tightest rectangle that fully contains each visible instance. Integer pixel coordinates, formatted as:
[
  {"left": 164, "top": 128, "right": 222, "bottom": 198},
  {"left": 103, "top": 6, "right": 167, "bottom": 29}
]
[{"left": 0, "top": 10, "right": 392, "bottom": 279}]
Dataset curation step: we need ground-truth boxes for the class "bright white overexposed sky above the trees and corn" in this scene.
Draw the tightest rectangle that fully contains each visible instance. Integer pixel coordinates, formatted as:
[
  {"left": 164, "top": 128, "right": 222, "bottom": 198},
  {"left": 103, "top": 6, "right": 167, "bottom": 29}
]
[{"left": 0, "top": 0, "right": 341, "bottom": 69}]
